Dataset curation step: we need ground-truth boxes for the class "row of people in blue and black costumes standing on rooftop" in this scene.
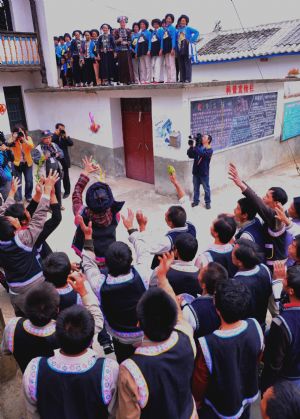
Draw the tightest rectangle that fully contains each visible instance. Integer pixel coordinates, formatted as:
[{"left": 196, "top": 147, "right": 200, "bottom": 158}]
[{"left": 54, "top": 13, "right": 199, "bottom": 87}]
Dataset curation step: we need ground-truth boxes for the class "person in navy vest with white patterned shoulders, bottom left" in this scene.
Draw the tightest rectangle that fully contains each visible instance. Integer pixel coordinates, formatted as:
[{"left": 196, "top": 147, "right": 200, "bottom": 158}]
[{"left": 23, "top": 306, "right": 118, "bottom": 419}]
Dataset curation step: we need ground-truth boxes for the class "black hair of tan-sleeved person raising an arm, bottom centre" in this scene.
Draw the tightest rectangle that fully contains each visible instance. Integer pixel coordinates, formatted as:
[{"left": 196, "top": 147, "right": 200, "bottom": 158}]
[{"left": 136, "top": 288, "right": 177, "bottom": 342}]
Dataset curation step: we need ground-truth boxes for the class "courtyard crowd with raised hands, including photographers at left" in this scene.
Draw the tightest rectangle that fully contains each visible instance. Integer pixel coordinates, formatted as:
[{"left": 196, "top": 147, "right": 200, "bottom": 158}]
[{"left": 0, "top": 124, "right": 300, "bottom": 419}]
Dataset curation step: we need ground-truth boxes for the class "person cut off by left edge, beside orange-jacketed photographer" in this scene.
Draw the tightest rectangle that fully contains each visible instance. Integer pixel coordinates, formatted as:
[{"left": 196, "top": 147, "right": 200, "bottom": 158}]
[{"left": 0, "top": 131, "right": 14, "bottom": 205}]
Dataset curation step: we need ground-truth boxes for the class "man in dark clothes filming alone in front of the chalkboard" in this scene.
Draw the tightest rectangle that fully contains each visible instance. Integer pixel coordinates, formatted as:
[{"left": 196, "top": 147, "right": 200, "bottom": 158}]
[{"left": 187, "top": 133, "right": 213, "bottom": 209}]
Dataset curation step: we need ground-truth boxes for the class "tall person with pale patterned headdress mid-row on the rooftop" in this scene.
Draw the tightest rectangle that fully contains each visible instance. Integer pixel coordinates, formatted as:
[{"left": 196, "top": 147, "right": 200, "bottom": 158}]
[{"left": 113, "top": 16, "right": 134, "bottom": 84}]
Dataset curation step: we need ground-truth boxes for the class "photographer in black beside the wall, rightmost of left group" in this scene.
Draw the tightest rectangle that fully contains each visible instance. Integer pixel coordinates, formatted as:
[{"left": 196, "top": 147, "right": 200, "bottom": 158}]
[{"left": 52, "top": 122, "right": 73, "bottom": 198}]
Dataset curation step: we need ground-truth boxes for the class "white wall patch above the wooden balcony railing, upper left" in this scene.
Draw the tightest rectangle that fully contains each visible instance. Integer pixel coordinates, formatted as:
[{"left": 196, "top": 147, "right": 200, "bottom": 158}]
[{"left": 9, "top": 0, "right": 34, "bottom": 32}]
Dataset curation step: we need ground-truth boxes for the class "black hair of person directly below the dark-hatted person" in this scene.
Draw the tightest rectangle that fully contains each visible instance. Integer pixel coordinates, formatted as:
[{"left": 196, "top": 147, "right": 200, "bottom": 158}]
[{"left": 105, "top": 242, "right": 132, "bottom": 276}]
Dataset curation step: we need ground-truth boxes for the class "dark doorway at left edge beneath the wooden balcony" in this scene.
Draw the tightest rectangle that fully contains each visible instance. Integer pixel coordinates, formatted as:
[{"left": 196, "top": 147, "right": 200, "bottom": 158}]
[{"left": 3, "top": 86, "right": 27, "bottom": 130}]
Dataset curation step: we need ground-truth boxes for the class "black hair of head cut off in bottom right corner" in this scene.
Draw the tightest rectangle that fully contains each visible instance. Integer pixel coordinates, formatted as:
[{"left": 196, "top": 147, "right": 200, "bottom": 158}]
[{"left": 266, "top": 380, "right": 300, "bottom": 419}]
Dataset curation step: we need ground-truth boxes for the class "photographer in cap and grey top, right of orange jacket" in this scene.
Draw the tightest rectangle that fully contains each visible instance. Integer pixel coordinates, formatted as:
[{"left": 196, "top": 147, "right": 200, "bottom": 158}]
[{"left": 32, "top": 130, "right": 64, "bottom": 210}]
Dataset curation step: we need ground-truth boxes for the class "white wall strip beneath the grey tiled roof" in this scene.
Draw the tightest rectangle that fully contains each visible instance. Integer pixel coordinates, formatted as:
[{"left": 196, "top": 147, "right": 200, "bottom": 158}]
[{"left": 193, "top": 55, "right": 300, "bottom": 82}]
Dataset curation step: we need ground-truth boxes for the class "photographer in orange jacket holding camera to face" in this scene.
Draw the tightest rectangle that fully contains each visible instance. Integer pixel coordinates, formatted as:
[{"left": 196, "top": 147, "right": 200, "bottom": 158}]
[{"left": 9, "top": 126, "right": 34, "bottom": 202}]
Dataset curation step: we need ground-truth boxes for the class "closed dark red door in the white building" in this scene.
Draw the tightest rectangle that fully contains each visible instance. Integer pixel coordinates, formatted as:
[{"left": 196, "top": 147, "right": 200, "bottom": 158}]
[{"left": 121, "top": 98, "right": 154, "bottom": 184}]
